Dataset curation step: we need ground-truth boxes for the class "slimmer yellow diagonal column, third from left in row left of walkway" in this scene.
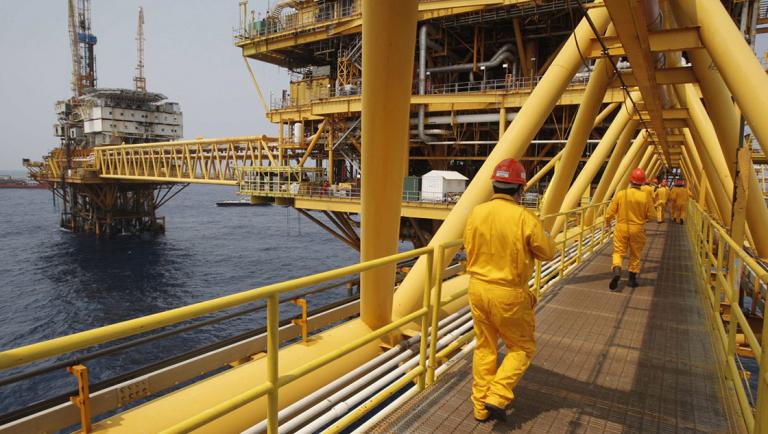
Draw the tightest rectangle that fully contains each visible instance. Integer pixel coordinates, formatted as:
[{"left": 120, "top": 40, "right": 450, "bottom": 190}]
[{"left": 544, "top": 99, "right": 642, "bottom": 236}]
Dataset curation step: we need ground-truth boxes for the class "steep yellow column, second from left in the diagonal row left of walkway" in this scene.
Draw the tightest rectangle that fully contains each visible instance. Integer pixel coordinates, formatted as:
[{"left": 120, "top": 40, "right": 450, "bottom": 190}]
[{"left": 540, "top": 25, "right": 623, "bottom": 220}]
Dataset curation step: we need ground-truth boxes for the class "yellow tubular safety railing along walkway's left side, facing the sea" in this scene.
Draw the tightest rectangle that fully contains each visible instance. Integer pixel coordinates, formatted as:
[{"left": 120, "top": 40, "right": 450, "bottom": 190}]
[{"left": 0, "top": 203, "right": 608, "bottom": 433}]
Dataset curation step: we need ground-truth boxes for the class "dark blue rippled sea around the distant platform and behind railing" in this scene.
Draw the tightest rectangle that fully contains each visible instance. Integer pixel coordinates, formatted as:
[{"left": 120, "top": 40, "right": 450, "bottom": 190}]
[{"left": 0, "top": 181, "right": 372, "bottom": 415}]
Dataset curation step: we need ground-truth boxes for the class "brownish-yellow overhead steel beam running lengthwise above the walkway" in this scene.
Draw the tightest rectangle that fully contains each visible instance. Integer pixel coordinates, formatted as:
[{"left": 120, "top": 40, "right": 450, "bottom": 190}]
[{"left": 605, "top": 0, "right": 668, "bottom": 160}]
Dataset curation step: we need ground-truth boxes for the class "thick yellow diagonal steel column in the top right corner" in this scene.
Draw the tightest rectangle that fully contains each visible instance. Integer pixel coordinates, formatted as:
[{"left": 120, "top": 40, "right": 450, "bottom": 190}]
[{"left": 670, "top": 0, "right": 768, "bottom": 154}]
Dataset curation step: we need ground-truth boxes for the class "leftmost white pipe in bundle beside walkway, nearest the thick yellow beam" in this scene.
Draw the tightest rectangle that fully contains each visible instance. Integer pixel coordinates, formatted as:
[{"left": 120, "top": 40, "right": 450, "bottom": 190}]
[{"left": 243, "top": 306, "right": 469, "bottom": 434}]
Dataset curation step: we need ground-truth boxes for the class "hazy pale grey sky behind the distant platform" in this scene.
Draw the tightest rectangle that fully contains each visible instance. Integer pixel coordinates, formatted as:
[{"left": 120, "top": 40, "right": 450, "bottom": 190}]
[{"left": 0, "top": 0, "right": 289, "bottom": 173}]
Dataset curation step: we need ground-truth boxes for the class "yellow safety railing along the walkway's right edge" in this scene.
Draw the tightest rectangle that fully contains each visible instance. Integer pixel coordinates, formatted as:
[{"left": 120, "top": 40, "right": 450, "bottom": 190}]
[{"left": 686, "top": 202, "right": 768, "bottom": 433}]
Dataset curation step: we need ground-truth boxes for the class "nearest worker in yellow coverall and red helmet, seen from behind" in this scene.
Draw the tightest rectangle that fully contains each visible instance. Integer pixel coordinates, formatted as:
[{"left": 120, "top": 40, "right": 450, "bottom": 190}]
[{"left": 464, "top": 159, "right": 555, "bottom": 421}]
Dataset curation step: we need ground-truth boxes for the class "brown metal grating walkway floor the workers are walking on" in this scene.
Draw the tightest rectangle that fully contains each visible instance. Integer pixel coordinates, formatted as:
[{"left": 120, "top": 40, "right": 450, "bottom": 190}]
[{"left": 372, "top": 223, "right": 744, "bottom": 433}]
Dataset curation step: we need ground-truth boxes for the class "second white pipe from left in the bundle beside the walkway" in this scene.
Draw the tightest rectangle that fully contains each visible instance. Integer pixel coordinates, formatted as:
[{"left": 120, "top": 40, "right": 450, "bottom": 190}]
[{"left": 294, "top": 321, "right": 472, "bottom": 434}]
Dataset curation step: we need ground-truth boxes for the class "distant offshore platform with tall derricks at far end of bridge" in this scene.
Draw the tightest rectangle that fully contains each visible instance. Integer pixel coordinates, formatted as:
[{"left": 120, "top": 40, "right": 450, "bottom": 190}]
[{"left": 24, "top": 0, "right": 183, "bottom": 237}]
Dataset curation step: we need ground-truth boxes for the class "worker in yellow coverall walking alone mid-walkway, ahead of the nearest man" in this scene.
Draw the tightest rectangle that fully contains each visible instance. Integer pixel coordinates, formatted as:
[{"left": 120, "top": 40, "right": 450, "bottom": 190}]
[{"left": 605, "top": 168, "right": 654, "bottom": 291}]
